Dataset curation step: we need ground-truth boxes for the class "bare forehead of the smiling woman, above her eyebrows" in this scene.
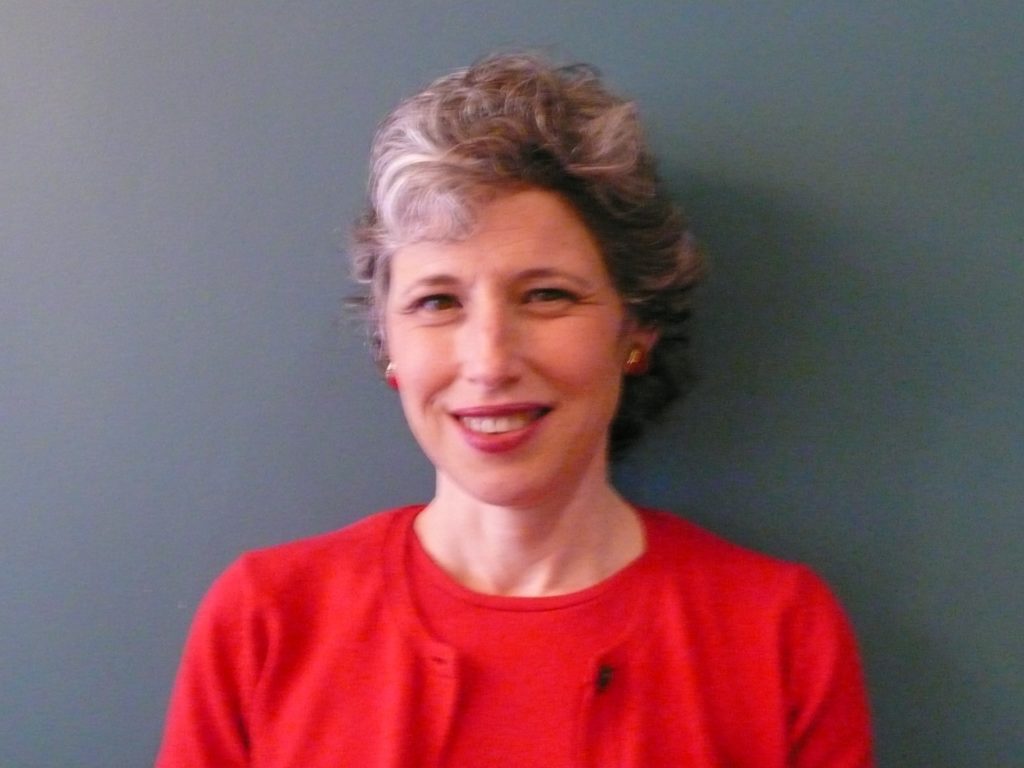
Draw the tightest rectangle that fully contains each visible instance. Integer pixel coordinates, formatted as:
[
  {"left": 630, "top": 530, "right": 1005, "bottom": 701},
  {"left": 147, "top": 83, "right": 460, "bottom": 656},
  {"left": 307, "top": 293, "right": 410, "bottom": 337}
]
[{"left": 391, "top": 189, "right": 607, "bottom": 284}]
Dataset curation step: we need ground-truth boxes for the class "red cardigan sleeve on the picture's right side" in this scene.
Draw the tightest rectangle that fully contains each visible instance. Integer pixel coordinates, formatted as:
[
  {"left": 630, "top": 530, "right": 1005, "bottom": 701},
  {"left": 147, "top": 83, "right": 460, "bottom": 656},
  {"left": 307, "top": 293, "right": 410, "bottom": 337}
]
[{"left": 783, "top": 568, "right": 874, "bottom": 768}]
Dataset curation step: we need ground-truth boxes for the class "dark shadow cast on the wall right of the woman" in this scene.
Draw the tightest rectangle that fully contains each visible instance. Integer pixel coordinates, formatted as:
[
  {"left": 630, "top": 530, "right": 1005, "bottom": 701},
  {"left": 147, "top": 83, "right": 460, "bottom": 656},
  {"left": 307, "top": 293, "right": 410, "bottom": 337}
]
[{"left": 616, "top": 170, "right": 1019, "bottom": 767}]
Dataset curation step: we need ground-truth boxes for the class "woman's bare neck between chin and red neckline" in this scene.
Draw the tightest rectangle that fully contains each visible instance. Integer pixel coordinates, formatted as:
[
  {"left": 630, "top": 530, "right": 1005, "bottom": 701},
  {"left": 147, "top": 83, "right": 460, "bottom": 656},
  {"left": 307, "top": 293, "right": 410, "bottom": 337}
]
[{"left": 416, "top": 474, "right": 644, "bottom": 597}]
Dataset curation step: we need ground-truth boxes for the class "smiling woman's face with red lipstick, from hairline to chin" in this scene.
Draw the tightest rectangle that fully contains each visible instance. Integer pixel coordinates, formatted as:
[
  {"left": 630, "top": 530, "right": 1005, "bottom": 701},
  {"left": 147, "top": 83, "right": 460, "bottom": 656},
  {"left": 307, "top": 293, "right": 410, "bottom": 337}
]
[{"left": 385, "top": 189, "right": 654, "bottom": 506}]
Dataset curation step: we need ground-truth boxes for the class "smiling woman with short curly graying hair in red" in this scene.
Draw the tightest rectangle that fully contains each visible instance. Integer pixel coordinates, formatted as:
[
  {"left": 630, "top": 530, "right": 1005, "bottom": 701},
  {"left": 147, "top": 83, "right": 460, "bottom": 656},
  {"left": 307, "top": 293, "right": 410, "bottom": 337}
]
[{"left": 158, "top": 55, "right": 870, "bottom": 768}]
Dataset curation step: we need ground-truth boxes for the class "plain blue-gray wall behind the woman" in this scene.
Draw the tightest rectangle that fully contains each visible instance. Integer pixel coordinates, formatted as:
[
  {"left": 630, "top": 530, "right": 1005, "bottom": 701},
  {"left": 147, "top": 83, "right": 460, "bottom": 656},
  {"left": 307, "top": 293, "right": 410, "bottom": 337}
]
[{"left": 0, "top": 0, "right": 1024, "bottom": 768}]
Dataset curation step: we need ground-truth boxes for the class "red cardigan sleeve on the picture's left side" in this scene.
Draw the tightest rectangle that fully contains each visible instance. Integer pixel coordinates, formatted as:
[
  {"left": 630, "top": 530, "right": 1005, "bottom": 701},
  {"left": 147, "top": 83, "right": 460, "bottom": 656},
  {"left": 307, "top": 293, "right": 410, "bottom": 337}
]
[{"left": 156, "top": 560, "right": 262, "bottom": 768}]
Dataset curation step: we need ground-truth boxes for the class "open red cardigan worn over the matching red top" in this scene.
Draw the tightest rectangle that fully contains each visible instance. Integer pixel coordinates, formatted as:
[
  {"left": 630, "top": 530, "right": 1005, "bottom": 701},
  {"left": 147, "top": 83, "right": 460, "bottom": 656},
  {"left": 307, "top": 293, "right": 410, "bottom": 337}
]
[{"left": 157, "top": 507, "right": 872, "bottom": 768}]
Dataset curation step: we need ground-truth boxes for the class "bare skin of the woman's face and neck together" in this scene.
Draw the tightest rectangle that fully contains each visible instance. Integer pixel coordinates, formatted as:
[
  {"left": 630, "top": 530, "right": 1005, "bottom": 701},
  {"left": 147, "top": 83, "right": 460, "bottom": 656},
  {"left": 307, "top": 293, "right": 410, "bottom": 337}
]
[{"left": 384, "top": 189, "right": 655, "bottom": 596}]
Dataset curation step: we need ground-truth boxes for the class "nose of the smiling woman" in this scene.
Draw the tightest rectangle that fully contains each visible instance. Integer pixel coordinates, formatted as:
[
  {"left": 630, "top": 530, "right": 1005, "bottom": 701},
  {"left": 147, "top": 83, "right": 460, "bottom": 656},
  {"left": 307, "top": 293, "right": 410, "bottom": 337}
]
[{"left": 459, "top": 297, "right": 521, "bottom": 389}]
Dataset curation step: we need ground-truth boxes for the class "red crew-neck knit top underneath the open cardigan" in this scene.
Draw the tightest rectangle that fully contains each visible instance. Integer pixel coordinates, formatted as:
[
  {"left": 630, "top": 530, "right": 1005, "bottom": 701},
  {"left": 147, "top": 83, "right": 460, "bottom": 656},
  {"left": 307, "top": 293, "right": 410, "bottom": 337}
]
[{"left": 409, "top": 520, "right": 645, "bottom": 768}]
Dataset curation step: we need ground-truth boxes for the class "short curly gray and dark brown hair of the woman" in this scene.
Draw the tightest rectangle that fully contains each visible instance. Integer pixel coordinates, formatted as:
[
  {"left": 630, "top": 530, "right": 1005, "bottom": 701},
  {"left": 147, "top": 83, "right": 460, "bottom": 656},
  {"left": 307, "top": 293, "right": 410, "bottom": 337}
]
[{"left": 351, "top": 53, "right": 705, "bottom": 457}]
